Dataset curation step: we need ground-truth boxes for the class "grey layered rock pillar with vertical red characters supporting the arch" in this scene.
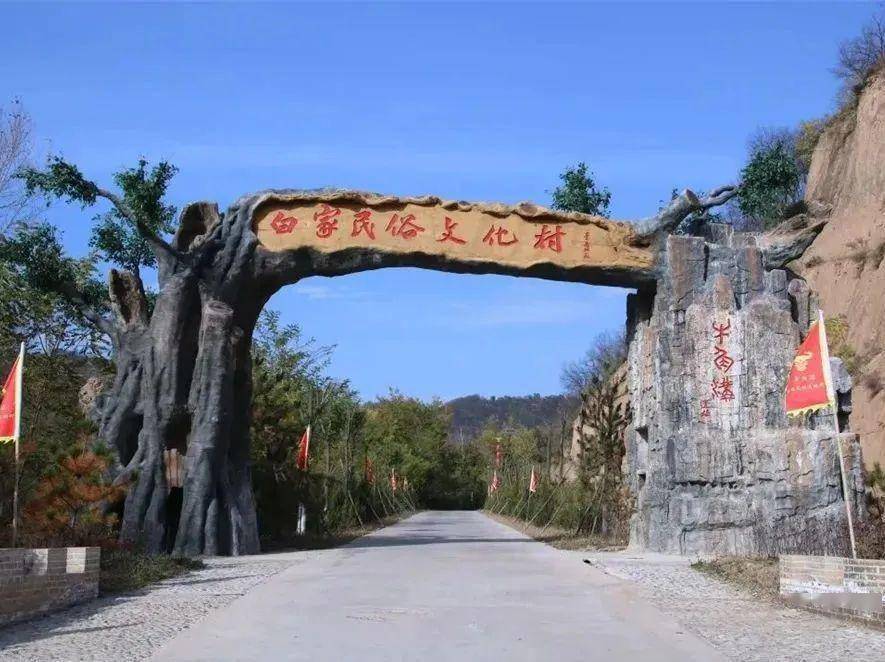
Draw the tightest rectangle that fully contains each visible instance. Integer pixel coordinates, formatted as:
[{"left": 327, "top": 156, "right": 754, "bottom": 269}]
[{"left": 624, "top": 225, "right": 863, "bottom": 554}]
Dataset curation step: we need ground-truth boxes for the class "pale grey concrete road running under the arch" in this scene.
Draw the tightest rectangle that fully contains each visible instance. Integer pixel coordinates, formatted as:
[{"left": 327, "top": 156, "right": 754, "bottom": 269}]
[{"left": 154, "top": 512, "right": 721, "bottom": 662}]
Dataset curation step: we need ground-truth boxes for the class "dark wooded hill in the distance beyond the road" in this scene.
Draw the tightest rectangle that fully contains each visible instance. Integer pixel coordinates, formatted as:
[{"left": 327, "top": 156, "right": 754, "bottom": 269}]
[{"left": 446, "top": 393, "right": 578, "bottom": 443}]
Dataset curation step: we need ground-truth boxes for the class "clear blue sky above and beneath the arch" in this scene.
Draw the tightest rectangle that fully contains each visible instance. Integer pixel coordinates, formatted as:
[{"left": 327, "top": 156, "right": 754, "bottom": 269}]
[{"left": 0, "top": 2, "right": 875, "bottom": 399}]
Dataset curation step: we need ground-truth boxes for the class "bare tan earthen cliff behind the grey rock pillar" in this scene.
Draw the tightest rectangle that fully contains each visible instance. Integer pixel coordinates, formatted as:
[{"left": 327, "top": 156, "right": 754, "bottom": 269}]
[{"left": 791, "top": 74, "right": 885, "bottom": 467}]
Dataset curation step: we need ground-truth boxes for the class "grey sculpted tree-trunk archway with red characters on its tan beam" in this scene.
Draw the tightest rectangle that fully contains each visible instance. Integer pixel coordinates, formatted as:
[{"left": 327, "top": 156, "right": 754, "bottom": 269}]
[{"left": 93, "top": 187, "right": 844, "bottom": 555}]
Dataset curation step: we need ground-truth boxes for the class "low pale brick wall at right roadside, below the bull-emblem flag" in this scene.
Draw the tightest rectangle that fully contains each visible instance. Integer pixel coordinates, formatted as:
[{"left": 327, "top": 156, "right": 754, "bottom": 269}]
[{"left": 780, "top": 555, "right": 885, "bottom": 627}]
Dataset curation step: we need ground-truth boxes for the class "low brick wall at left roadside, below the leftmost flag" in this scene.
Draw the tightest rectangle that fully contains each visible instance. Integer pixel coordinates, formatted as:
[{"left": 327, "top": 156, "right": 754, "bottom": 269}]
[{"left": 0, "top": 547, "right": 101, "bottom": 625}]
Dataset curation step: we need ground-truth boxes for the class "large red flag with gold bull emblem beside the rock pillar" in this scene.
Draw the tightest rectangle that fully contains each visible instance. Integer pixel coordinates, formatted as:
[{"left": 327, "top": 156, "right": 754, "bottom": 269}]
[{"left": 786, "top": 313, "right": 835, "bottom": 416}]
